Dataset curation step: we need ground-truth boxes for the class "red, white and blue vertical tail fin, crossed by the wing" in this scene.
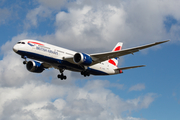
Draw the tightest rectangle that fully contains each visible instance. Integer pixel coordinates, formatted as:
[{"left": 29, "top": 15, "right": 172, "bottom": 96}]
[{"left": 108, "top": 42, "right": 123, "bottom": 67}]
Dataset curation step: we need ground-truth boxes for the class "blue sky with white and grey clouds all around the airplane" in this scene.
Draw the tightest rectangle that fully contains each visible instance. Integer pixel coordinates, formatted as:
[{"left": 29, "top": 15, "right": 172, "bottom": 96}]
[{"left": 0, "top": 0, "right": 180, "bottom": 120}]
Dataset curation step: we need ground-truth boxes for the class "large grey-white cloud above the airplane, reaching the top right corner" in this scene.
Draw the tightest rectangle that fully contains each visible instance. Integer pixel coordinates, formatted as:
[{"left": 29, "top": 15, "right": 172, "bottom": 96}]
[{"left": 40, "top": 0, "right": 179, "bottom": 53}]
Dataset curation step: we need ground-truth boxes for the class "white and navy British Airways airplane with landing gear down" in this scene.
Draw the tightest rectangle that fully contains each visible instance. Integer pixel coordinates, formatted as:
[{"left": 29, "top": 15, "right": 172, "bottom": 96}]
[{"left": 13, "top": 39, "right": 169, "bottom": 80}]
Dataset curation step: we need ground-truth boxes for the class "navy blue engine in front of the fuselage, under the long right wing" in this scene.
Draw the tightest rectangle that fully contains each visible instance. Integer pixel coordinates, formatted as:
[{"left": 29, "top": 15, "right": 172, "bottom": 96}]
[{"left": 74, "top": 53, "right": 92, "bottom": 66}]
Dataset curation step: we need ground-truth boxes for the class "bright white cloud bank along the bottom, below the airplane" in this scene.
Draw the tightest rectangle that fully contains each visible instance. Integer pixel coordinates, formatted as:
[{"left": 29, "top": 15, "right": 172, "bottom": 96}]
[{"left": 0, "top": 80, "right": 155, "bottom": 120}]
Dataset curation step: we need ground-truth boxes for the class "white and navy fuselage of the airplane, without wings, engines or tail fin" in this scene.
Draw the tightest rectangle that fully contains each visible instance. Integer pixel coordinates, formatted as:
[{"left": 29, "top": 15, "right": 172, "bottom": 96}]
[{"left": 13, "top": 39, "right": 117, "bottom": 75}]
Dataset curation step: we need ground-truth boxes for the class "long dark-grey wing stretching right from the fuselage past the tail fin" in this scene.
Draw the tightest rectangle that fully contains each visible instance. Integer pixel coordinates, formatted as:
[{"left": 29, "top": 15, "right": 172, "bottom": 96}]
[{"left": 90, "top": 40, "right": 169, "bottom": 65}]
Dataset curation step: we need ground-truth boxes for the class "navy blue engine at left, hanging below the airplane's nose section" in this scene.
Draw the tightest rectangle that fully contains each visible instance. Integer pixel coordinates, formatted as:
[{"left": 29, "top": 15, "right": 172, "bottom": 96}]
[{"left": 26, "top": 61, "right": 44, "bottom": 73}]
